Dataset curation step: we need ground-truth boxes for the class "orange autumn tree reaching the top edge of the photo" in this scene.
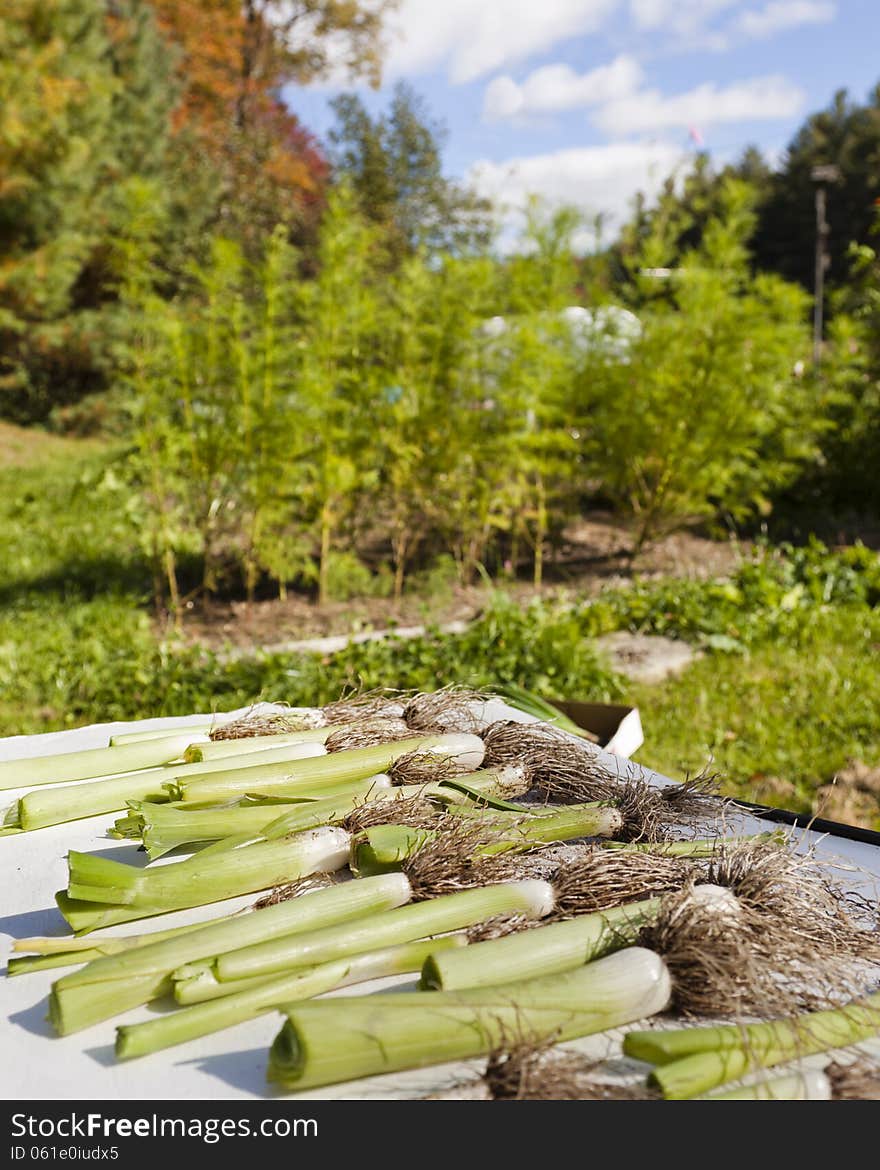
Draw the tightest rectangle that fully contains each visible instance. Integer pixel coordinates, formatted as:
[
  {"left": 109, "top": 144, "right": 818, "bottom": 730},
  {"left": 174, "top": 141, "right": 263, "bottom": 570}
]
[{"left": 153, "top": 0, "right": 387, "bottom": 253}]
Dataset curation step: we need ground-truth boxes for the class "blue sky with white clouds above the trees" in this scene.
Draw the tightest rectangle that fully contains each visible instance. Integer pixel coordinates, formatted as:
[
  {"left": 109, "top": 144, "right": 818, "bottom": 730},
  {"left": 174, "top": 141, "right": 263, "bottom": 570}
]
[{"left": 284, "top": 0, "right": 880, "bottom": 242}]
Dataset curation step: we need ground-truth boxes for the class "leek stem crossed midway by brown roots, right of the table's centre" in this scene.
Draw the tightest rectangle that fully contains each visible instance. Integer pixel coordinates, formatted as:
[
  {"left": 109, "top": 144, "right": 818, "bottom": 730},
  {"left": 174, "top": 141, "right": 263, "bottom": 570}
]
[{"left": 351, "top": 803, "right": 624, "bottom": 874}]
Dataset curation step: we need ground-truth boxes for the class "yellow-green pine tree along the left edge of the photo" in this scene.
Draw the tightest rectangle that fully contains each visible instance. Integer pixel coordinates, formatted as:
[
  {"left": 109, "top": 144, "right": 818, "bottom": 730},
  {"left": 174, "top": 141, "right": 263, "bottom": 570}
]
[{"left": 0, "top": 0, "right": 174, "bottom": 420}]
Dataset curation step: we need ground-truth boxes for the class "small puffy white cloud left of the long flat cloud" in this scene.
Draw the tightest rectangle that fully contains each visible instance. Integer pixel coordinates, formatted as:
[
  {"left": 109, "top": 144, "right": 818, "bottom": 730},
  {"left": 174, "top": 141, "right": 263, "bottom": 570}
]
[{"left": 483, "top": 55, "right": 642, "bottom": 121}]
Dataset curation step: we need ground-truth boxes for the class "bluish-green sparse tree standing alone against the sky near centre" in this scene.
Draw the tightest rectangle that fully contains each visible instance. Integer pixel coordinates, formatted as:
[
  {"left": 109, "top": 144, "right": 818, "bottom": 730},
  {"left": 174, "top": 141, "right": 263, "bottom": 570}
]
[{"left": 329, "top": 82, "right": 490, "bottom": 260}]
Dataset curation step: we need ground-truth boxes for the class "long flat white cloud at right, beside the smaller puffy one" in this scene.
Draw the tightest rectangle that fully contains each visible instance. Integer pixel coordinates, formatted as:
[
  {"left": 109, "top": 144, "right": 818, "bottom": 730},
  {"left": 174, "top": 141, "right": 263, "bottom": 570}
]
[{"left": 593, "top": 76, "right": 806, "bottom": 135}]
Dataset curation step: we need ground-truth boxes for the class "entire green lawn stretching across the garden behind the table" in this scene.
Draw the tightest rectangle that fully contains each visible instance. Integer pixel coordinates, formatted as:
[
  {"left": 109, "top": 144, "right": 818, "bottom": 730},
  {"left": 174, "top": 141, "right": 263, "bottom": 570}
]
[{"left": 0, "top": 426, "right": 880, "bottom": 824}]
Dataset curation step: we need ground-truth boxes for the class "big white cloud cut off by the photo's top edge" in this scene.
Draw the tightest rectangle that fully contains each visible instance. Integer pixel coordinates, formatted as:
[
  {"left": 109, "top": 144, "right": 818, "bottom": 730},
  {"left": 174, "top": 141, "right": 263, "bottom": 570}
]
[{"left": 387, "top": 0, "right": 620, "bottom": 83}]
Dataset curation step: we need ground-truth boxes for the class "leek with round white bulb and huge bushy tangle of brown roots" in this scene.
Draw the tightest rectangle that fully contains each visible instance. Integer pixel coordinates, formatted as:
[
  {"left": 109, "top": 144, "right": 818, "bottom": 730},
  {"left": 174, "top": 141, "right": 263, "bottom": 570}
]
[{"left": 422, "top": 841, "right": 880, "bottom": 1016}]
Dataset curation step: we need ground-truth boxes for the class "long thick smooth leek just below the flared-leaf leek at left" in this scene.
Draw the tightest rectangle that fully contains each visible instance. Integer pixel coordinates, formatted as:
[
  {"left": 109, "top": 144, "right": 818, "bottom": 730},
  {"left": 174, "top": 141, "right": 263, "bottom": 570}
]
[{"left": 49, "top": 874, "right": 411, "bottom": 1035}]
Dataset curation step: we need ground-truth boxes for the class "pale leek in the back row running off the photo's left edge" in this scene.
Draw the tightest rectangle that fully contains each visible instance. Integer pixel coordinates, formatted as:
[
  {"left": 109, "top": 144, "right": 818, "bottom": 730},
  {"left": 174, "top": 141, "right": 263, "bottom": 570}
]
[{"left": 4, "top": 743, "right": 325, "bottom": 831}]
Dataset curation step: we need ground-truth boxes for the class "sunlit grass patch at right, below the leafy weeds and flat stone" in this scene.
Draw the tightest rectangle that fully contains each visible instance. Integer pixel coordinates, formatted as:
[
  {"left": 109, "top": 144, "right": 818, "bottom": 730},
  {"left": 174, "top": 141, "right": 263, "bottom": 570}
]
[{"left": 628, "top": 611, "right": 880, "bottom": 827}]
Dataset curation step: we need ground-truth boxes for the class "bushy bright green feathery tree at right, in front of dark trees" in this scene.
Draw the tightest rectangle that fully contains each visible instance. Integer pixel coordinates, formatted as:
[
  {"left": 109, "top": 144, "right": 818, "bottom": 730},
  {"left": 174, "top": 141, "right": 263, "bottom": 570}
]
[{"left": 578, "top": 179, "right": 821, "bottom": 552}]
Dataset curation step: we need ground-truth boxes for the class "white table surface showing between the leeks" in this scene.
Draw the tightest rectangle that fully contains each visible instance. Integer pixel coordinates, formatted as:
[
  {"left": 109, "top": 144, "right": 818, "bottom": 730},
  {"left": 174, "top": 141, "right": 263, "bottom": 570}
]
[{"left": 0, "top": 704, "right": 880, "bottom": 1101}]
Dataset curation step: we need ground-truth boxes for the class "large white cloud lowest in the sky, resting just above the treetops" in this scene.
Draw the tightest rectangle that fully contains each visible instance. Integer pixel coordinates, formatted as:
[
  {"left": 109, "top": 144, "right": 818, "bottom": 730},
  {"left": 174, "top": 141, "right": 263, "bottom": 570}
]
[{"left": 468, "top": 142, "right": 685, "bottom": 246}]
